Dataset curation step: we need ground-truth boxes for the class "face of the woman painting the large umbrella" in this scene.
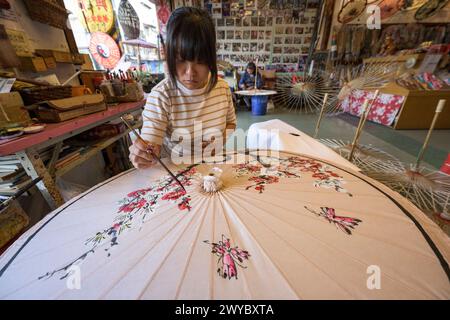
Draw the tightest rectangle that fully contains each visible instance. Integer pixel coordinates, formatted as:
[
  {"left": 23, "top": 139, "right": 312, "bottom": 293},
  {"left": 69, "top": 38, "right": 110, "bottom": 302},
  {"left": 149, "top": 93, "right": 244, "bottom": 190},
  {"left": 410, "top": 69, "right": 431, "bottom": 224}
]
[{"left": 177, "top": 58, "right": 209, "bottom": 90}]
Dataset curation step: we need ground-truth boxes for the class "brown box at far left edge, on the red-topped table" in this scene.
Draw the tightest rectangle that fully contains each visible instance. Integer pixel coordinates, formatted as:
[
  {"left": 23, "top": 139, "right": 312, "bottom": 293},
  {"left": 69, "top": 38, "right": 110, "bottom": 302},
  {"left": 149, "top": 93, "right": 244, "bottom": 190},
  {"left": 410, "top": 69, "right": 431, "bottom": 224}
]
[{"left": 0, "top": 92, "right": 31, "bottom": 126}]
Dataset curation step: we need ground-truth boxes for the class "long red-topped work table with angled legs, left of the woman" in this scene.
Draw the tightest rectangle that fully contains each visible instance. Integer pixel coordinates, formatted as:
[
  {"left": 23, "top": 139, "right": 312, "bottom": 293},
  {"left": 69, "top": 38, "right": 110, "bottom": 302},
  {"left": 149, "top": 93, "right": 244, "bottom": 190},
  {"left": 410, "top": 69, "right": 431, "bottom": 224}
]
[{"left": 0, "top": 100, "right": 145, "bottom": 209}]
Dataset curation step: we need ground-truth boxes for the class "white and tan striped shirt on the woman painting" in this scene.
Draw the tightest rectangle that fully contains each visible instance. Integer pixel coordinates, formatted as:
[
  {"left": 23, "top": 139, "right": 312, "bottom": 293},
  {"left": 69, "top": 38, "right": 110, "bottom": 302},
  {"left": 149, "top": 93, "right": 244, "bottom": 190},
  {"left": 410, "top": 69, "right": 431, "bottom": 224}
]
[{"left": 141, "top": 79, "right": 236, "bottom": 158}]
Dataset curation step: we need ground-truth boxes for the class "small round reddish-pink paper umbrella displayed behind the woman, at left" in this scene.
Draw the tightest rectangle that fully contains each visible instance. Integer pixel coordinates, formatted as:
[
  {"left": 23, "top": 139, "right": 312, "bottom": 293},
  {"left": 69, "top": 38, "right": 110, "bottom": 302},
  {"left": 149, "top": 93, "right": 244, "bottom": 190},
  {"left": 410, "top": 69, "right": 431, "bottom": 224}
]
[{"left": 89, "top": 32, "right": 120, "bottom": 69}]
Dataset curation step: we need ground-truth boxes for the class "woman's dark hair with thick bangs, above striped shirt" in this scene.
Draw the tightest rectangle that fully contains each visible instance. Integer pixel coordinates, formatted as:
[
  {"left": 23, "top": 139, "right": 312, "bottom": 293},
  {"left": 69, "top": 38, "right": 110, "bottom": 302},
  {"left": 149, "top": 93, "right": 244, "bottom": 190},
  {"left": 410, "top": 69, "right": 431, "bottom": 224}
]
[{"left": 165, "top": 7, "right": 217, "bottom": 92}]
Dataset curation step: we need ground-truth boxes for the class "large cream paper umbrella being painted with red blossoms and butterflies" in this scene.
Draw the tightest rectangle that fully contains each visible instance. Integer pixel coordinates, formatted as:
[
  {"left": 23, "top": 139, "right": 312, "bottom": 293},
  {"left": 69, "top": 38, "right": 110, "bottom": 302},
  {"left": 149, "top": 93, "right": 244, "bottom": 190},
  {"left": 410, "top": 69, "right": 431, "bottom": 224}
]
[{"left": 0, "top": 153, "right": 450, "bottom": 299}]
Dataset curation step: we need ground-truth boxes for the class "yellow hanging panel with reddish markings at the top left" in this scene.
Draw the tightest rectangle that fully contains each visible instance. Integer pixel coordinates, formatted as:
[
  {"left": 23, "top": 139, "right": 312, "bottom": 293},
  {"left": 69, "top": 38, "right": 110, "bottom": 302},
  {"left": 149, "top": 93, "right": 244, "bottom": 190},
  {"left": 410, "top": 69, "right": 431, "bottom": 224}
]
[{"left": 78, "top": 0, "right": 114, "bottom": 33}]
